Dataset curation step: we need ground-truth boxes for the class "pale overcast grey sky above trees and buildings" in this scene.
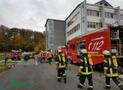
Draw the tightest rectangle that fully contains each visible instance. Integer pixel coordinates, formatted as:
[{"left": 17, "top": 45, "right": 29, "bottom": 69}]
[{"left": 0, "top": 0, "right": 123, "bottom": 31}]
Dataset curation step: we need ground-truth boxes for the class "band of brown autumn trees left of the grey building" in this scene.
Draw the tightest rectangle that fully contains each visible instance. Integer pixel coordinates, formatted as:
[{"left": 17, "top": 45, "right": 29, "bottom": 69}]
[{"left": 0, "top": 25, "right": 45, "bottom": 51}]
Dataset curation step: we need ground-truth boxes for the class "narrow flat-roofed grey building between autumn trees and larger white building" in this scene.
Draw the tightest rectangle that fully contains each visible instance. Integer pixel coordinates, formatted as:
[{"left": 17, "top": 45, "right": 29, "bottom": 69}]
[{"left": 45, "top": 19, "right": 66, "bottom": 51}]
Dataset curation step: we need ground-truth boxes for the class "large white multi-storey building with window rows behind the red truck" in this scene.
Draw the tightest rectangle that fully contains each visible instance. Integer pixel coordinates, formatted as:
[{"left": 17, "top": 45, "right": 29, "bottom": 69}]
[{"left": 66, "top": 0, "right": 123, "bottom": 42}]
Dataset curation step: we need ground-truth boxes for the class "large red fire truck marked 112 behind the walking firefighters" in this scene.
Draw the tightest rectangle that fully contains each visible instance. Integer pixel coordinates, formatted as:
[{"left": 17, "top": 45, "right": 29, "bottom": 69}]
[{"left": 67, "top": 26, "right": 123, "bottom": 65}]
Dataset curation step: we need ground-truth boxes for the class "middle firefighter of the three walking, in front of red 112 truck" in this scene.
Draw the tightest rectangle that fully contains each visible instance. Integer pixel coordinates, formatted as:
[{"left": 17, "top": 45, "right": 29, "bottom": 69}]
[{"left": 78, "top": 49, "right": 93, "bottom": 90}]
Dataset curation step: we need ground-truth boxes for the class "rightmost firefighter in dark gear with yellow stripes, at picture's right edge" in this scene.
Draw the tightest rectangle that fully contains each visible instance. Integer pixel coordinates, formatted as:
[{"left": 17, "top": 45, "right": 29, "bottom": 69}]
[{"left": 103, "top": 50, "right": 123, "bottom": 90}]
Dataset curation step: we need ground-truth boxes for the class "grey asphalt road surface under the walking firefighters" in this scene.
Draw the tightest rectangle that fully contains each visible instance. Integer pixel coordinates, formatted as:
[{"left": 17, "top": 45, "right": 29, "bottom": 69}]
[{"left": 0, "top": 60, "right": 119, "bottom": 90}]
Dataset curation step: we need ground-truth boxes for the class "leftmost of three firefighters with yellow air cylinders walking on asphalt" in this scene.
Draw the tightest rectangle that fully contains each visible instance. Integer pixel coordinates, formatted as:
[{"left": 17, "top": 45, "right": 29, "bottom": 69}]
[{"left": 55, "top": 50, "right": 67, "bottom": 83}]
